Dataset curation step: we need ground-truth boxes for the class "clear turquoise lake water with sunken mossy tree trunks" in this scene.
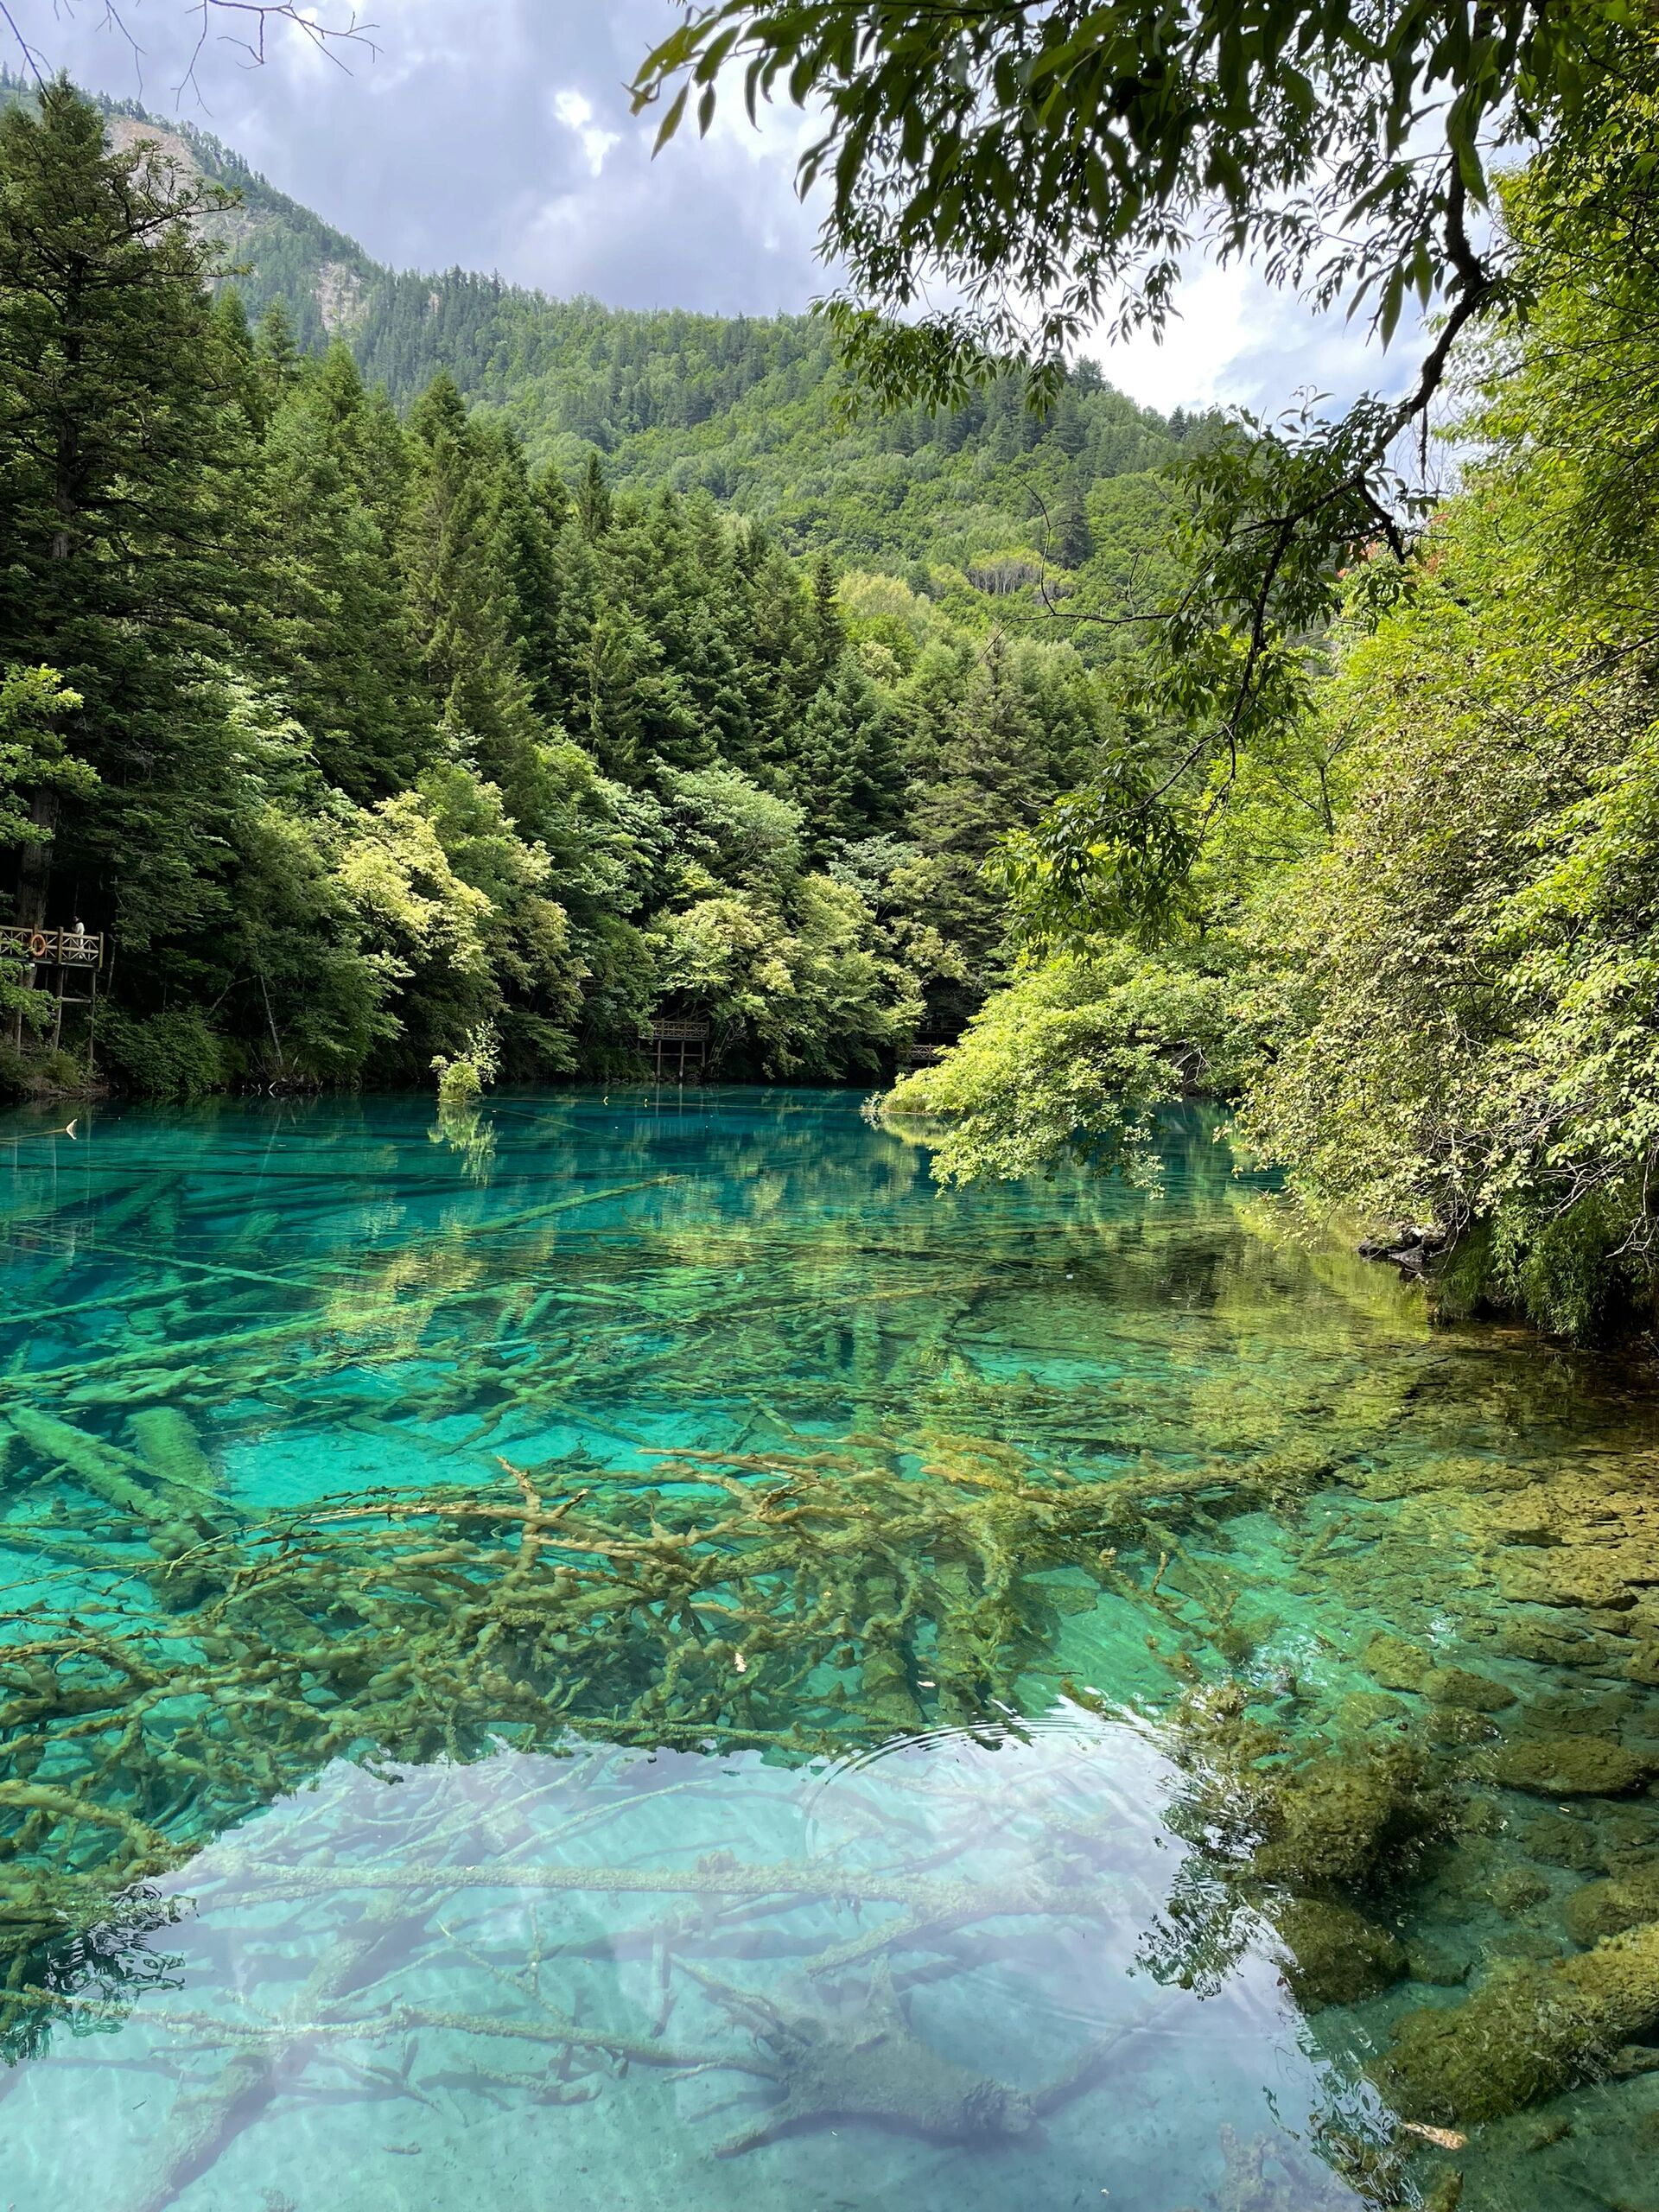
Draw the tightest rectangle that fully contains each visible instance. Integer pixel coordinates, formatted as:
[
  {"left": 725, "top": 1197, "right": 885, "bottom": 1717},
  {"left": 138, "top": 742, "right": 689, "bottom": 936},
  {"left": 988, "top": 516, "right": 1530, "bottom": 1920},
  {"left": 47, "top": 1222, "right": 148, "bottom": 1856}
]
[{"left": 0, "top": 1090, "right": 1659, "bottom": 2212}]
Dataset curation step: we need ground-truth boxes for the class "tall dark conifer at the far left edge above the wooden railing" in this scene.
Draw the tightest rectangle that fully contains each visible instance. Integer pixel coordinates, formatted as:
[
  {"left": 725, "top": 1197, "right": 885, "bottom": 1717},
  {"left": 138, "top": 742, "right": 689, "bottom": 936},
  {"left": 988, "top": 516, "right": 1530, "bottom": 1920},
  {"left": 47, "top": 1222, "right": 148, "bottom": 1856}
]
[{"left": 0, "top": 79, "right": 261, "bottom": 943}]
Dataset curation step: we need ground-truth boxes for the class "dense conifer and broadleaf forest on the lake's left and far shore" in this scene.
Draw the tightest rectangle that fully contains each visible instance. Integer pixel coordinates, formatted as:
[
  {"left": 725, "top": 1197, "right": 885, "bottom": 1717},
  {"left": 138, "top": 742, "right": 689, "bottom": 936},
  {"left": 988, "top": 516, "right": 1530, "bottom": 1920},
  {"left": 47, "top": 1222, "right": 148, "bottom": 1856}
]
[{"left": 0, "top": 84, "right": 1132, "bottom": 1093}]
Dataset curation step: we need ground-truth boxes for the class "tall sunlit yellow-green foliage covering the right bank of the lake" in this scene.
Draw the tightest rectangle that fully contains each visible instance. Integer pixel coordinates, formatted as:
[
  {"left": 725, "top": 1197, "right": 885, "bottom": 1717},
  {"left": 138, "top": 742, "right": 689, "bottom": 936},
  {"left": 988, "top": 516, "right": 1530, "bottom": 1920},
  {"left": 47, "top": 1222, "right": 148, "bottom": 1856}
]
[{"left": 1252, "top": 64, "right": 1659, "bottom": 1336}]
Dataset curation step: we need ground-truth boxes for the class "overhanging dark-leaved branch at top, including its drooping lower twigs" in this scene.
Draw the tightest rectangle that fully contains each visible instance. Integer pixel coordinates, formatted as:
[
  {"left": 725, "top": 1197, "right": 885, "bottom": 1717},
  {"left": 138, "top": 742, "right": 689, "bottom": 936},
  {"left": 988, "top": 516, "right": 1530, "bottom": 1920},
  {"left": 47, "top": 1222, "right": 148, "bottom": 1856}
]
[{"left": 635, "top": 0, "right": 1655, "bottom": 936}]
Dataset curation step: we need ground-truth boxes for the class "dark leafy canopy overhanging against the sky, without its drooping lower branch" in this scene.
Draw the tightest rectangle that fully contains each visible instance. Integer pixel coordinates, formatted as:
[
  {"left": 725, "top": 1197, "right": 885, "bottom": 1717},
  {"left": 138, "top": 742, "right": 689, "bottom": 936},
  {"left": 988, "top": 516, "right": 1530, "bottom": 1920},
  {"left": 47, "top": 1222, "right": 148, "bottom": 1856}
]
[{"left": 635, "top": 0, "right": 1632, "bottom": 396}]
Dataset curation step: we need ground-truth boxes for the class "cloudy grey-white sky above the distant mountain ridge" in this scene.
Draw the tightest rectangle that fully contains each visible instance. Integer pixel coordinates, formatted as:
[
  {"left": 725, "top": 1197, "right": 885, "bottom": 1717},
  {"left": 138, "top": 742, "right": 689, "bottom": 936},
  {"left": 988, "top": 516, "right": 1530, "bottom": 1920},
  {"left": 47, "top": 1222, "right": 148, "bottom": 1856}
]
[{"left": 9, "top": 0, "right": 1411, "bottom": 411}]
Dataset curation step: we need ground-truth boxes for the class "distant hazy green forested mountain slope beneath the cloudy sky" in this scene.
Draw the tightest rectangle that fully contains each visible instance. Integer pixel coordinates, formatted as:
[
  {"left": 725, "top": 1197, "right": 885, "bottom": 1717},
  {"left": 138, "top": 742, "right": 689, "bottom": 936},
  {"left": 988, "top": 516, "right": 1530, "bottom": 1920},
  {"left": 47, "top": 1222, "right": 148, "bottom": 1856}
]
[{"left": 9, "top": 82, "right": 1201, "bottom": 588}]
